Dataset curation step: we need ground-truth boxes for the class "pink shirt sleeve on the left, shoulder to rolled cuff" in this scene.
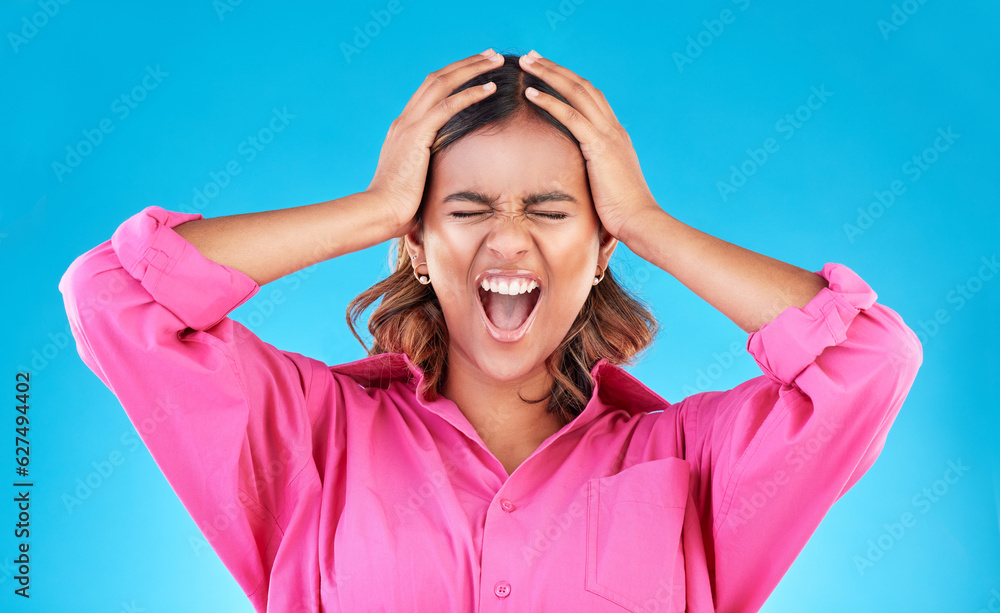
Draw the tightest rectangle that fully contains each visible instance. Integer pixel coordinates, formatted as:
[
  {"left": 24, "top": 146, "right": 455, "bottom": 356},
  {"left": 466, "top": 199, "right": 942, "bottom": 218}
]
[{"left": 59, "top": 206, "right": 322, "bottom": 610}]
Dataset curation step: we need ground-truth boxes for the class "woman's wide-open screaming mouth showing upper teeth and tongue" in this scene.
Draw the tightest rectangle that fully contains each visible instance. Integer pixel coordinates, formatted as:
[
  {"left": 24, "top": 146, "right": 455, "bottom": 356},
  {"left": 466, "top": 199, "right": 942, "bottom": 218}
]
[{"left": 478, "top": 276, "right": 542, "bottom": 343}]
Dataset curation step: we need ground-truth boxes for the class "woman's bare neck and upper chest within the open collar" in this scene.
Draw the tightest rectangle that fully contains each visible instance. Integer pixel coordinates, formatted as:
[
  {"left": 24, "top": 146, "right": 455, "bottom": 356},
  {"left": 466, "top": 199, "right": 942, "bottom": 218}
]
[{"left": 442, "top": 352, "right": 566, "bottom": 474}]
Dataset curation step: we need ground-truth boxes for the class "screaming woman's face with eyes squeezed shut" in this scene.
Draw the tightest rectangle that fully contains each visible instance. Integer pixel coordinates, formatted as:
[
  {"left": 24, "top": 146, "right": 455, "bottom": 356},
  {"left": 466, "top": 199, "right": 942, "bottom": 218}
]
[{"left": 406, "top": 118, "right": 617, "bottom": 388}]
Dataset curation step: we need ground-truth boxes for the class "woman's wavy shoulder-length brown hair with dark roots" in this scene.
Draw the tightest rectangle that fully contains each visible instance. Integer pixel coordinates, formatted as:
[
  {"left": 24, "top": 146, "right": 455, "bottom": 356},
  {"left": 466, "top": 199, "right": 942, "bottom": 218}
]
[{"left": 347, "top": 54, "right": 657, "bottom": 422}]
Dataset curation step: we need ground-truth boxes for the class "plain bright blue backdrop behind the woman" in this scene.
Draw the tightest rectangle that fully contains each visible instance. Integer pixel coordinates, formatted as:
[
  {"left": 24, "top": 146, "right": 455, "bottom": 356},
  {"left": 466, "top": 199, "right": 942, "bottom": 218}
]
[{"left": 0, "top": 0, "right": 1000, "bottom": 612}]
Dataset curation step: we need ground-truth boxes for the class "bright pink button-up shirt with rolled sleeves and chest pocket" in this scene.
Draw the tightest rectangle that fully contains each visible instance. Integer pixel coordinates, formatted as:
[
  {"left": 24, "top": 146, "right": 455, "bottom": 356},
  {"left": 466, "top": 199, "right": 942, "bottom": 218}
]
[{"left": 59, "top": 206, "right": 922, "bottom": 613}]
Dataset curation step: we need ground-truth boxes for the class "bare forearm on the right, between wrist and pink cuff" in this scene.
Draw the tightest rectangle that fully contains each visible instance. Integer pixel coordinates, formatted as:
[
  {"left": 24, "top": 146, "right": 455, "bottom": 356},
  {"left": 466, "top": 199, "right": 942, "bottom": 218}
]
[{"left": 622, "top": 207, "right": 827, "bottom": 332}]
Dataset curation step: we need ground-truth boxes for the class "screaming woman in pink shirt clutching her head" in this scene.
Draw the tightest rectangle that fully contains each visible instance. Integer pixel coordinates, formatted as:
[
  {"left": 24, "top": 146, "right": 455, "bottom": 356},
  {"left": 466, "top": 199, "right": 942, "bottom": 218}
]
[{"left": 60, "top": 50, "right": 921, "bottom": 612}]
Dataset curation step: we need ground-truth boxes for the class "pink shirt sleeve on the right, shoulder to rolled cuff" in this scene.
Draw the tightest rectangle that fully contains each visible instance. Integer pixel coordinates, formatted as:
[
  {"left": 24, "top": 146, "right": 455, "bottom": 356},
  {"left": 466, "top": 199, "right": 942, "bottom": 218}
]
[{"left": 679, "top": 263, "right": 922, "bottom": 611}]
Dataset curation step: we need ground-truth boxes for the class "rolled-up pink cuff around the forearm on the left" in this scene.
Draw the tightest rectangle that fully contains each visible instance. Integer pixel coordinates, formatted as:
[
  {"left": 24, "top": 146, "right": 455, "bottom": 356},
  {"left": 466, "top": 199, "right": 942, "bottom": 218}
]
[{"left": 111, "top": 206, "right": 260, "bottom": 330}]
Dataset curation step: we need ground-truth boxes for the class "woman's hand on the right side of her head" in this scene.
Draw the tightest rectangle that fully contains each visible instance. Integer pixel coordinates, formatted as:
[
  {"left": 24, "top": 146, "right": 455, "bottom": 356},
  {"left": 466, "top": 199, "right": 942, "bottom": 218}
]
[{"left": 520, "top": 51, "right": 662, "bottom": 245}]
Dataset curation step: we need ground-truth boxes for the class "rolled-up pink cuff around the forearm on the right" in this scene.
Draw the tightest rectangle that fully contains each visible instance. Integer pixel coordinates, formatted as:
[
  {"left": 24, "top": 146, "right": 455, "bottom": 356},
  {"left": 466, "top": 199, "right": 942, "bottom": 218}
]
[{"left": 747, "top": 263, "right": 878, "bottom": 385}]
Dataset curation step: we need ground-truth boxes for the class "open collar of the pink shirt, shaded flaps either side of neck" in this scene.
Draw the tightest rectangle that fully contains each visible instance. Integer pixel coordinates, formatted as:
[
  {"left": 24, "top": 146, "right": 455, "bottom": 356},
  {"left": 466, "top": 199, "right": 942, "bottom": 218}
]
[{"left": 330, "top": 353, "right": 670, "bottom": 431}]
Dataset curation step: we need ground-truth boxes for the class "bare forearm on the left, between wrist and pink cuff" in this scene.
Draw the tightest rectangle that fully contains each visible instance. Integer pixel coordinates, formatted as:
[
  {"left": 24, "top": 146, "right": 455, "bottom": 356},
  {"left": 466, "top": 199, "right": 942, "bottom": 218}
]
[{"left": 173, "top": 192, "right": 395, "bottom": 285}]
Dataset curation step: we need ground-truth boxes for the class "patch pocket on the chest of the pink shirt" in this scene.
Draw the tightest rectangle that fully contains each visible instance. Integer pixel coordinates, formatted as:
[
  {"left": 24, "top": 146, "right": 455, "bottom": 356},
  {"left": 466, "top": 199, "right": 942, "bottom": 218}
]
[{"left": 584, "top": 458, "right": 690, "bottom": 613}]
